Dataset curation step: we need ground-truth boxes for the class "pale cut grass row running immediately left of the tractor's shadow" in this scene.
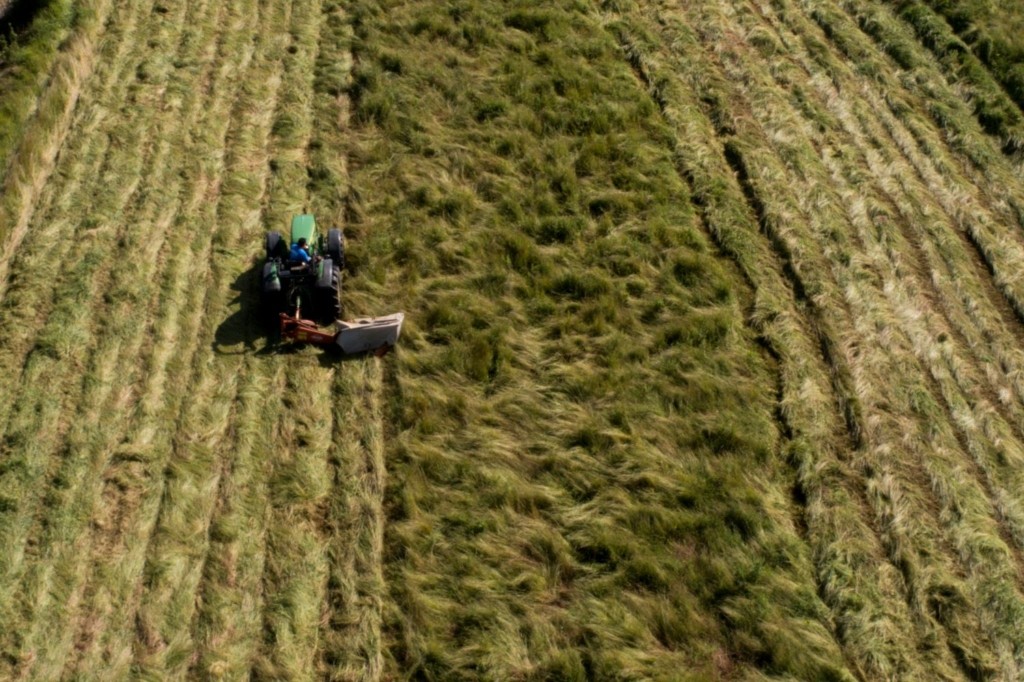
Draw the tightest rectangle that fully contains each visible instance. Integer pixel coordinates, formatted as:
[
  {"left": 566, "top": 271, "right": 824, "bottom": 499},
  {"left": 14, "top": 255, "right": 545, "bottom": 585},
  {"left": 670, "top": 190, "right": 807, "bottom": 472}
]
[{"left": 125, "top": 4, "right": 282, "bottom": 676}]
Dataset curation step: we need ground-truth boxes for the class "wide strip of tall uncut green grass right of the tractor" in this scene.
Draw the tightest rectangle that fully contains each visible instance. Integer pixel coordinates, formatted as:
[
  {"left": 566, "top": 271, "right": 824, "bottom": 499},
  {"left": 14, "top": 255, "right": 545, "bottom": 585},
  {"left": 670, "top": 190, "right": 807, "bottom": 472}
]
[{"left": 348, "top": 3, "right": 848, "bottom": 679}]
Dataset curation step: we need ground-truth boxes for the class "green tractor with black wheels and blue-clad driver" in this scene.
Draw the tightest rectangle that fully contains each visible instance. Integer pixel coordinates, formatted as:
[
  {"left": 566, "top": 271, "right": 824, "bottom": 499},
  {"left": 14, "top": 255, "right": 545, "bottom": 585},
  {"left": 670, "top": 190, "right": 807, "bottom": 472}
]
[{"left": 262, "top": 214, "right": 345, "bottom": 324}]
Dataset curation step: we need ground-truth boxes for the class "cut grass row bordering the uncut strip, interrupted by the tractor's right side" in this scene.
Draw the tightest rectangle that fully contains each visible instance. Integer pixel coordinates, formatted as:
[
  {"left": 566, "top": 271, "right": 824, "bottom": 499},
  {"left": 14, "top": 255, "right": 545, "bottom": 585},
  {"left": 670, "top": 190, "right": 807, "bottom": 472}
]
[{"left": 299, "top": 1, "right": 389, "bottom": 680}]
